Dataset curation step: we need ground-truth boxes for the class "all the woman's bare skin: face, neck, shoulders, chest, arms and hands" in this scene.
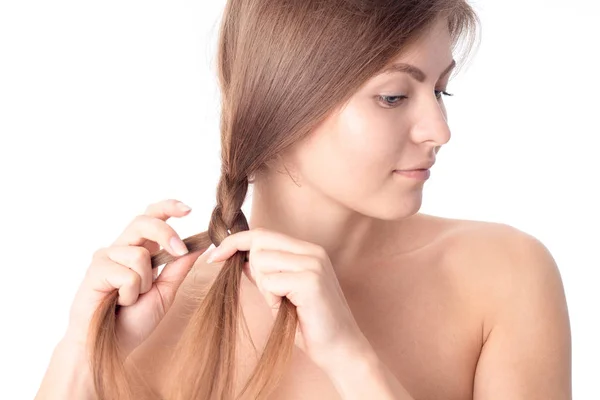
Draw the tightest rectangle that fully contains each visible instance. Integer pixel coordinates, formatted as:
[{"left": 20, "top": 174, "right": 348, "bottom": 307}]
[{"left": 38, "top": 14, "right": 571, "bottom": 400}]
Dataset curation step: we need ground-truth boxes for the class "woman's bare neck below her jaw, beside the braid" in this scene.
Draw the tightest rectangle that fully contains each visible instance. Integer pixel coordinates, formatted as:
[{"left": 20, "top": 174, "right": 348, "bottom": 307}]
[{"left": 248, "top": 170, "right": 414, "bottom": 273}]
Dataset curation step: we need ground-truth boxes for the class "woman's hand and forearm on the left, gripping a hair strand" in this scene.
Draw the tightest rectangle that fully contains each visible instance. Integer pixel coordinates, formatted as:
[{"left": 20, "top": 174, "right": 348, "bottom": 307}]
[{"left": 36, "top": 199, "right": 200, "bottom": 399}]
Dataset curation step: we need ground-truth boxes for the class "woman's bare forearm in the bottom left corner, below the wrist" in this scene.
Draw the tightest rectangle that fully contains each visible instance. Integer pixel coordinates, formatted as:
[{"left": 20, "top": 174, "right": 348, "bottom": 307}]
[{"left": 35, "top": 339, "right": 95, "bottom": 400}]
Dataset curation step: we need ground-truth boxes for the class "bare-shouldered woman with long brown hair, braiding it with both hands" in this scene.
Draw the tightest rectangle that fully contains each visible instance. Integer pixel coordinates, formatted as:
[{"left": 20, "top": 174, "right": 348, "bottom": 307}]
[{"left": 37, "top": 0, "right": 571, "bottom": 400}]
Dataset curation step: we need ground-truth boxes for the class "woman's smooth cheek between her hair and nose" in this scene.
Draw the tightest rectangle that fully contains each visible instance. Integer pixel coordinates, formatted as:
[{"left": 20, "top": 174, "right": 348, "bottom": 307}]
[{"left": 294, "top": 103, "right": 406, "bottom": 201}]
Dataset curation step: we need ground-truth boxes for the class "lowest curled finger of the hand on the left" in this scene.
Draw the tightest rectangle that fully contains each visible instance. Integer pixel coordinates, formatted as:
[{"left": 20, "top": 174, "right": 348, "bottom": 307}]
[{"left": 87, "top": 258, "right": 142, "bottom": 306}]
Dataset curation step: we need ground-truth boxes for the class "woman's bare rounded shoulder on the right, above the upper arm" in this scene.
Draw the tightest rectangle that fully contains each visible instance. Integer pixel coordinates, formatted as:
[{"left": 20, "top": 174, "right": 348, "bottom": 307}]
[{"left": 414, "top": 215, "right": 566, "bottom": 328}]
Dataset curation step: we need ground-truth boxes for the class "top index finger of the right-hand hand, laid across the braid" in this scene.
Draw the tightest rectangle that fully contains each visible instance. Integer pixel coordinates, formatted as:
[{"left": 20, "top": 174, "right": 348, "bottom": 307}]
[{"left": 210, "top": 228, "right": 325, "bottom": 262}]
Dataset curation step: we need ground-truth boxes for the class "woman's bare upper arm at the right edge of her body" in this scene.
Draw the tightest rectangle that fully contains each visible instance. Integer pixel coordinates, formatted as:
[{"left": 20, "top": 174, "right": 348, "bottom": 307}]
[{"left": 474, "top": 229, "right": 572, "bottom": 400}]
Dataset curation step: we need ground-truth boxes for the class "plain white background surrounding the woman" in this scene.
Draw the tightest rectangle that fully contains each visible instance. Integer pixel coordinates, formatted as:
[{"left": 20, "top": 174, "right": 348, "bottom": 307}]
[{"left": 0, "top": 0, "right": 600, "bottom": 399}]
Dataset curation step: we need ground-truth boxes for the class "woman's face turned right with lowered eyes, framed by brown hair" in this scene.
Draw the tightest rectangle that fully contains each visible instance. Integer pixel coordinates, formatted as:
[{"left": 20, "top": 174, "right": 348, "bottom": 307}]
[{"left": 285, "top": 19, "right": 453, "bottom": 220}]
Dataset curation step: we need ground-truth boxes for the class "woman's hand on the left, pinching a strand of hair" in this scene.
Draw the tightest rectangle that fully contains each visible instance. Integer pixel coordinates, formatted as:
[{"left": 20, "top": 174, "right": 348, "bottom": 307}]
[{"left": 64, "top": 200, "right": 206, "bottom": 356}]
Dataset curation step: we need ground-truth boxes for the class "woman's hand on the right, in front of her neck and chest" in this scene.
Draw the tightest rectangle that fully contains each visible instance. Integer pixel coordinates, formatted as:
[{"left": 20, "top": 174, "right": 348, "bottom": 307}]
[{"left": 209, "top": 228, "right": 371, "bottom": 370}]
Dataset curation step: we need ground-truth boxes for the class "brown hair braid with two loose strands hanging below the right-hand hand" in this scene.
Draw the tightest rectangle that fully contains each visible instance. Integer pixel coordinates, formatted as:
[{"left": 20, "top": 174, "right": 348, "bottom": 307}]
[{"left": 172, "top": 173, "right": 297, "bottom": 400}]
